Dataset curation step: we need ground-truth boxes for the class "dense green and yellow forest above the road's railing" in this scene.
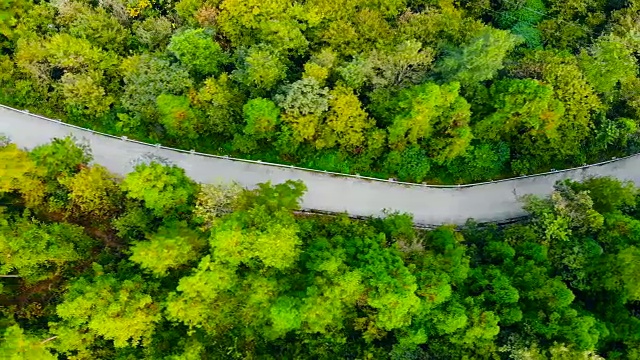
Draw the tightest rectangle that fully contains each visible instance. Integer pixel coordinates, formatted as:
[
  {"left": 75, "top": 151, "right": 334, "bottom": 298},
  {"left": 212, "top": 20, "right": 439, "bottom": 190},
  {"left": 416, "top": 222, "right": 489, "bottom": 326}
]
[{"left": 0, "top": 0, "right": 640, "bottom": 182}]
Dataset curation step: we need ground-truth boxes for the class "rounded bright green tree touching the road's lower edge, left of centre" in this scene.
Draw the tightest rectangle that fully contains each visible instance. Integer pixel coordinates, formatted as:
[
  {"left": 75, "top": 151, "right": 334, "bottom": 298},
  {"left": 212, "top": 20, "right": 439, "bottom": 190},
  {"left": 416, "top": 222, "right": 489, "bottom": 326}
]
[{"left": 122, "top": 162, "right": 197, "bottom": 217}]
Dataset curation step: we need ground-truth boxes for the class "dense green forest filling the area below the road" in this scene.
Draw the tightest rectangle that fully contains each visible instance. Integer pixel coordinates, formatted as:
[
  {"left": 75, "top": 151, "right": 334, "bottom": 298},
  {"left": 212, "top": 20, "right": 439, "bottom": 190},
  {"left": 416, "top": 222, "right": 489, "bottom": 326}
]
[{"left": 0, "top": 139, "right": 640, "bottom": 360}]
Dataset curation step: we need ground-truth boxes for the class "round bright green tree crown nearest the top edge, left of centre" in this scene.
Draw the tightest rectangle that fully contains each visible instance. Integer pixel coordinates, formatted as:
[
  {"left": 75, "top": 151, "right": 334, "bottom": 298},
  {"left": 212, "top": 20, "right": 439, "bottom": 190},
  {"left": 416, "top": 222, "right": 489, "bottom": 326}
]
[{"left": 167, "top": 29, "right": 226, "bottom": 77}]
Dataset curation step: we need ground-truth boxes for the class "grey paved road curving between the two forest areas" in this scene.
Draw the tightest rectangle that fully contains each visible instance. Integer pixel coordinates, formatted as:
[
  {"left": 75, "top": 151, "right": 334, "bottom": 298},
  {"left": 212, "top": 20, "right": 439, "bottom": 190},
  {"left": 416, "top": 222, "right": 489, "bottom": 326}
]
[{"left": 0, "top": 107, "right": 640, "bottom": 225}]
